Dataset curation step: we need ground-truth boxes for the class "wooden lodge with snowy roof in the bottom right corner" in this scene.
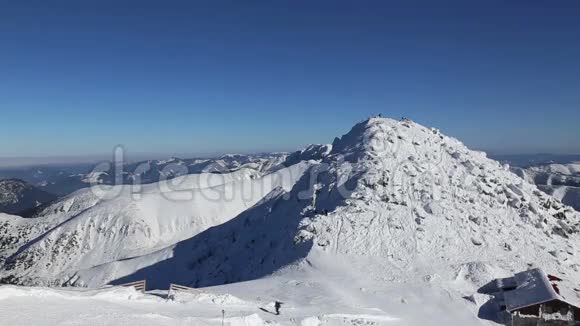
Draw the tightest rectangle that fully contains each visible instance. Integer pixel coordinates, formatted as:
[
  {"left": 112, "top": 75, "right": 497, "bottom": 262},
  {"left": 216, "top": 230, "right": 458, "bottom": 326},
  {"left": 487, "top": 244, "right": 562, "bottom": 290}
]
[{"left": 497, "top": 268, "right": 580, "bottom": 326}]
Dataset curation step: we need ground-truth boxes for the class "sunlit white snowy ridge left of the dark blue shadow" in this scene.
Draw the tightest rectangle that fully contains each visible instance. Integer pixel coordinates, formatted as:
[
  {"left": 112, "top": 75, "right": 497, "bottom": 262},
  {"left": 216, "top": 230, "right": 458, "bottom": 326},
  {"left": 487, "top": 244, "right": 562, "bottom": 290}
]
[{"left": 0, "top": 163, "right": 308, "bottom": 284}]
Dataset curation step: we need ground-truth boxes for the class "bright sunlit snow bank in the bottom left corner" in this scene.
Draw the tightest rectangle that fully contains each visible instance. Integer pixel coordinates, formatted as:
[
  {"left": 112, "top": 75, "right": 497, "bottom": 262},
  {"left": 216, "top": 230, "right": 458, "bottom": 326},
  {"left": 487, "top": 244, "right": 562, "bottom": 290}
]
[{"left": 0, "top": 286, "right": 271, "bottom": 326}]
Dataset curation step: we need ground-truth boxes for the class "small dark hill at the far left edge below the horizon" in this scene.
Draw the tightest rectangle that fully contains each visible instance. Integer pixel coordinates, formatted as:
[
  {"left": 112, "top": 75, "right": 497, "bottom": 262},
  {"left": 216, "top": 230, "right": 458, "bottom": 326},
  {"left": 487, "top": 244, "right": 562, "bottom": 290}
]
[{"left": 0, "top": 179, "right": 56, "bottom": 214}]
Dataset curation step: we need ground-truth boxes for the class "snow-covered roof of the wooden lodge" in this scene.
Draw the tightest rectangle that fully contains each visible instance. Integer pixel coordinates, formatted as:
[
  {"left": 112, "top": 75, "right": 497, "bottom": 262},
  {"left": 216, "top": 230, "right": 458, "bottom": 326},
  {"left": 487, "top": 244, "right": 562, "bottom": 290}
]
[{"left": 504, "top": 268, "right": 567, "bottom": 312}]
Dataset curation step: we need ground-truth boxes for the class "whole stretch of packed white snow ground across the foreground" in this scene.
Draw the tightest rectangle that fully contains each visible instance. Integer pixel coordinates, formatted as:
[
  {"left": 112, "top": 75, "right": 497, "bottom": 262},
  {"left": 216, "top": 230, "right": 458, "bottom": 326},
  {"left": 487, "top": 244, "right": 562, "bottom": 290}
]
[{"left": 0, "top": 261, "right": 488, "bottom": 326}]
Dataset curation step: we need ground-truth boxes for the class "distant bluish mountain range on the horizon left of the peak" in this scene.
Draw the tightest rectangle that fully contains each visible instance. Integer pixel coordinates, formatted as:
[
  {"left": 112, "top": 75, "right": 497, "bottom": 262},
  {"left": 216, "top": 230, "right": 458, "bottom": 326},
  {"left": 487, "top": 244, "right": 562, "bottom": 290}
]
[{"left": 0, "top": 150, "right": 340, "bottom": 217}]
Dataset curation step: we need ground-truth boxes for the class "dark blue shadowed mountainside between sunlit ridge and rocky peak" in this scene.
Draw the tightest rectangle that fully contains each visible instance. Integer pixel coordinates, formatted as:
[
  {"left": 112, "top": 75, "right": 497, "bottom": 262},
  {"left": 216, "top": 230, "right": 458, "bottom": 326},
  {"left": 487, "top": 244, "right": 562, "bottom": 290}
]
[{"left": 106, "top": 167, "right": 324, "bottom": 289}]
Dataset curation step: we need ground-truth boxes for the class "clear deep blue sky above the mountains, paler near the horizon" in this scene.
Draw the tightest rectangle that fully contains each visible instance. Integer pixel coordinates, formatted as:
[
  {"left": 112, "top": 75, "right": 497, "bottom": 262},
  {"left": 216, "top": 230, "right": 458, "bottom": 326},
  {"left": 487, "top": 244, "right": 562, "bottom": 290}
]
[{"left": 0, "top": 0, "right": 580, "bottom": 157}]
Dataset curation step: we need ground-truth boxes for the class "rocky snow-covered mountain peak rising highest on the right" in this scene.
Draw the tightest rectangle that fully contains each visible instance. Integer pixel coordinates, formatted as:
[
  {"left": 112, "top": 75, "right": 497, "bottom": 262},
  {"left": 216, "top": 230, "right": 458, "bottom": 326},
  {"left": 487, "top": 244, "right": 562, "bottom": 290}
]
[{"left": 298, "top": 117, "right": 579, "bottom": 277}]
